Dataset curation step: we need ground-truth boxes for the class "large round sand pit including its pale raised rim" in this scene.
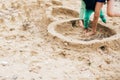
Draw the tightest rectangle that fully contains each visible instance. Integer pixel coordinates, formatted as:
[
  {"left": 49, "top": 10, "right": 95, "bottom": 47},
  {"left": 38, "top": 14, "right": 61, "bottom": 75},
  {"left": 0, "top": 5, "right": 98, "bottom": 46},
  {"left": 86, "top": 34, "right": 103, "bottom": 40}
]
[{"left": 48, "top": 18, "right": 120, "bottom": 49}]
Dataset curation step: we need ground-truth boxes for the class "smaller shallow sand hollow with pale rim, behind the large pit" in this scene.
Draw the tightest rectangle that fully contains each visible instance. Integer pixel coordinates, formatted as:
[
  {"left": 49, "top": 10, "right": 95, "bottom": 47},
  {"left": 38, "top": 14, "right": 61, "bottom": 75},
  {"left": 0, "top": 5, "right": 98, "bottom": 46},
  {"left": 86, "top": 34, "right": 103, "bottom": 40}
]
[{"left": 47, "top": 6, "right": 79, "bottom": 20}]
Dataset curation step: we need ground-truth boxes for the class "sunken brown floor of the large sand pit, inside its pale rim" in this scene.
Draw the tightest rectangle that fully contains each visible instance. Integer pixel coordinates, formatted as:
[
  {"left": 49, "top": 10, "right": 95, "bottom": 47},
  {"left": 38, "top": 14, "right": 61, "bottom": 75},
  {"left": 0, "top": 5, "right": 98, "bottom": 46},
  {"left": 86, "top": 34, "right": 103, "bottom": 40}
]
[{"left": 55, "top": 21, "right": 116, "bottom": 41}]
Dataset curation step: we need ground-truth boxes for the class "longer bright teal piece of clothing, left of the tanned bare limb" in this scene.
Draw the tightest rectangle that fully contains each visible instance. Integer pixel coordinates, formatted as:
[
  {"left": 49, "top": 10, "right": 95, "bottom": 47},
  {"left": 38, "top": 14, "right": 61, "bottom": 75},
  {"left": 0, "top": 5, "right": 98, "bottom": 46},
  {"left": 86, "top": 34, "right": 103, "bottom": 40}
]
[{"left": 84, "top": 9, "right": 94, "bottom": 29}]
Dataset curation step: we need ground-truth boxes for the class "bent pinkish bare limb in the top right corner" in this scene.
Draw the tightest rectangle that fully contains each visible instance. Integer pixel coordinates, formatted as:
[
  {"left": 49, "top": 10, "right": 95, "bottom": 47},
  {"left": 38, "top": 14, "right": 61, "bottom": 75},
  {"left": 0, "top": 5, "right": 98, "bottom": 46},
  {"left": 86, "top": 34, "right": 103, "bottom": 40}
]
[{"left": 107, "top": 0, "right": 120, "bottom": 17}]
